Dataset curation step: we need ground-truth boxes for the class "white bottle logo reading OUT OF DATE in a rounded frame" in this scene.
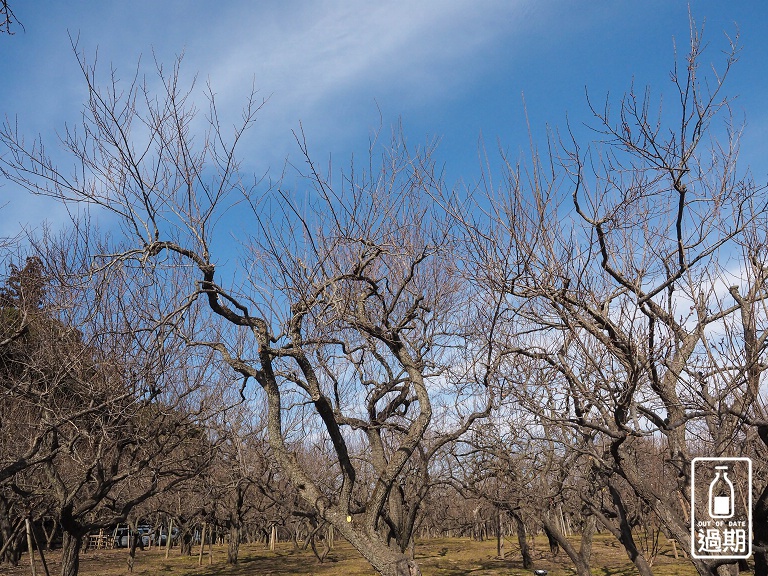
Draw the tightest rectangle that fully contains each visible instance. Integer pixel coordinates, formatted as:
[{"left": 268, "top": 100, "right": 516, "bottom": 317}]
[{"left": 691, "top": 458, "right": 752, "bottom": 560}]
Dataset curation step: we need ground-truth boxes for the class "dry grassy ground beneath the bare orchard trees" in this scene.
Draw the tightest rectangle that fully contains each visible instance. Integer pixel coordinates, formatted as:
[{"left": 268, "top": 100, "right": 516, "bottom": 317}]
[{"left": 0, "top": 534, "right": 720, "bottom": 576}]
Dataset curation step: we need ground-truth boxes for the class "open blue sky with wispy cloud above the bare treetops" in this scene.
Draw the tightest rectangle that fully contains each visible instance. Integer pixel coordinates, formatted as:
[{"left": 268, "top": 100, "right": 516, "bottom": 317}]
[{"left": 0, "top": 0, "right": 768, "bottom": 237}]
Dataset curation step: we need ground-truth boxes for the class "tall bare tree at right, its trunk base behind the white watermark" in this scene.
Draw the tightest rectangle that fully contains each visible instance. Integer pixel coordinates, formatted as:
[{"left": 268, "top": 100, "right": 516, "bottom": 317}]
[{"left": 456, "top": 26, "right": 767, "bottom": 574}]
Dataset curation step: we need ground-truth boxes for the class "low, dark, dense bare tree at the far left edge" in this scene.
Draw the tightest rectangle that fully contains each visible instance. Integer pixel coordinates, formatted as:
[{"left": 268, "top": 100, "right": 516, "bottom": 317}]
[{"left": 0, "top": 227, "right": 218, "bottom": 576}]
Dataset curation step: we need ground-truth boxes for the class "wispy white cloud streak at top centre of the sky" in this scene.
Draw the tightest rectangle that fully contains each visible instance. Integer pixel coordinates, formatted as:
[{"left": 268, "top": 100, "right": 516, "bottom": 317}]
[{"left": 188, "top": 0, "right": 528, "bottom": 154}]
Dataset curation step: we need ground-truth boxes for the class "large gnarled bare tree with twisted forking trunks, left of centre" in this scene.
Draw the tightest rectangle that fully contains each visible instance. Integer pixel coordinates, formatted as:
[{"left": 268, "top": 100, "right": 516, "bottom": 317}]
[{"left": 0, "top": 48, "right": 496, "bottom": 576}]
